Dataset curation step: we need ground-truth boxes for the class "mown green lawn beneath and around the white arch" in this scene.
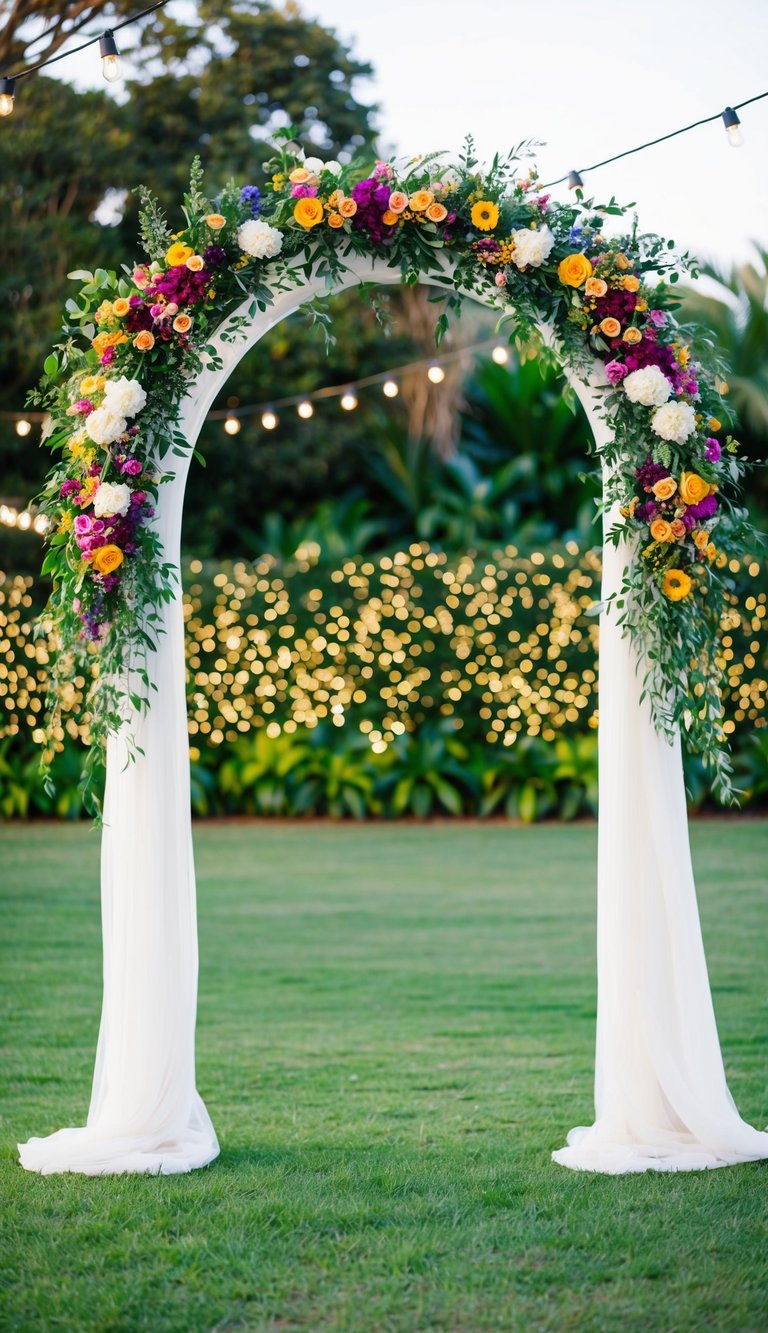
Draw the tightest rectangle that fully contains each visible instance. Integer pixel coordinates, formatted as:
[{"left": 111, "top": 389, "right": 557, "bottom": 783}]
[{"left": 0, "top": 820, "right": 768, "bottom": 1333}]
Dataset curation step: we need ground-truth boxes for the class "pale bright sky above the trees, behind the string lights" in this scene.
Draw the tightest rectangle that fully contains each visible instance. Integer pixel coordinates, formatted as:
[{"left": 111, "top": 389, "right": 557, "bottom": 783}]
[{"left": 57, "top": 0, "right": 768, "bottom": 268}]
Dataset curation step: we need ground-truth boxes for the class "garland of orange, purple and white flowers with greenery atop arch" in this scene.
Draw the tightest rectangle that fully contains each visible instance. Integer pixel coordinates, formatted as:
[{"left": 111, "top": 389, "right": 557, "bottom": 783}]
[{"left": 32, "top": 132, "right": 747, "bottom": 792}]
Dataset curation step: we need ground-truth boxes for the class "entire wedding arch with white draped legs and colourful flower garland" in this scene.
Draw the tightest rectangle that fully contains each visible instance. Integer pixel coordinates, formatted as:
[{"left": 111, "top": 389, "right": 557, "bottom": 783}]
[{"left": 20, "top": 145, "right": 768, "bottom": 1174}]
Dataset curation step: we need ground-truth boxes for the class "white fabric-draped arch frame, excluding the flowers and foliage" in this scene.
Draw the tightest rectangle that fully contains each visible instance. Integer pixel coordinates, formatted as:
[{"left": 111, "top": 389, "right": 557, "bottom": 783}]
[{"left": 20, "top": 256, "right": 768, "bottom": 1174}]
